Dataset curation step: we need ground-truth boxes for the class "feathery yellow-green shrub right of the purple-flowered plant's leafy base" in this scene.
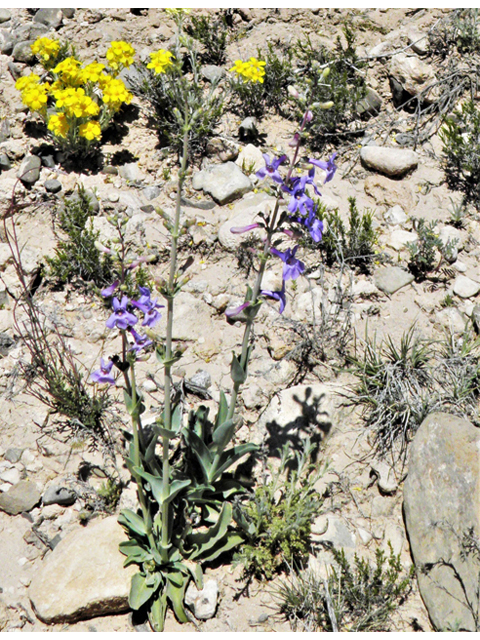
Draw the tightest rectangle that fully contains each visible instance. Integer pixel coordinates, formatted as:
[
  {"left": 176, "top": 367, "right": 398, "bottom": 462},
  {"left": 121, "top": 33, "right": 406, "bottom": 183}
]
[{"left": 234, "top": 441, "right": 322, "bottom": 580}]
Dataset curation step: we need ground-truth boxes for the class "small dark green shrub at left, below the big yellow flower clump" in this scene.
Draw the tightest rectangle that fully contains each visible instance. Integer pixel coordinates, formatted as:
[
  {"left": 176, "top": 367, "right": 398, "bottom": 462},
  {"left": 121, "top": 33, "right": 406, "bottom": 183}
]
[{"left": 46, "top": 187, "right": 113, "bottom": 287}]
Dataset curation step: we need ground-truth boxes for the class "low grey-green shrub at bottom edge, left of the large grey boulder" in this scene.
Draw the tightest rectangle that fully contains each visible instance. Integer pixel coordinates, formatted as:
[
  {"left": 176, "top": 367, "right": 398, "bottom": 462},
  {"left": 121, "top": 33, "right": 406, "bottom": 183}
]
[{"left": 276, "top": 544, "right": 414, "bottom": 632}]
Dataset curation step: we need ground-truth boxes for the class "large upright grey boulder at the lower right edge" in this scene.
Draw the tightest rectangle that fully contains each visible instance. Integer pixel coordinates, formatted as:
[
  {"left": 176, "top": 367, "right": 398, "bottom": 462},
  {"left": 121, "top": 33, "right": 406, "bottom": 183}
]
[{"left": 404, "top": 413, "right": 480, "bottom": 631}]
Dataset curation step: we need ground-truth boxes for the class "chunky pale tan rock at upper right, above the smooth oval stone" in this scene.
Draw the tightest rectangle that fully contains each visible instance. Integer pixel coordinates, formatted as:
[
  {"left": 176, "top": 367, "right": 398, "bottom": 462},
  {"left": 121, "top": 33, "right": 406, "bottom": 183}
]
[{"left": 389, "top": 53, "right": 438, "bottom": 102}]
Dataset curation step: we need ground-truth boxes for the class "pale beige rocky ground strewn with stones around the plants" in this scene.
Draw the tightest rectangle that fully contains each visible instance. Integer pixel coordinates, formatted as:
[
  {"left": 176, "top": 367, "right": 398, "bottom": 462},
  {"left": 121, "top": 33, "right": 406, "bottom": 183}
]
[{"left": 0, "top": 9, "right": 480, "bottom": 631}]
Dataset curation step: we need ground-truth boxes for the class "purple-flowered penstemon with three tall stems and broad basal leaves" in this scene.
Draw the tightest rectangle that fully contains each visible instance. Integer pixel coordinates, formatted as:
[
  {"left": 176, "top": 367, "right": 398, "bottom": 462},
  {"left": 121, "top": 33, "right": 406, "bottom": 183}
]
[{"left": 92, "top": 14, "right": 336, "bottom": 631}]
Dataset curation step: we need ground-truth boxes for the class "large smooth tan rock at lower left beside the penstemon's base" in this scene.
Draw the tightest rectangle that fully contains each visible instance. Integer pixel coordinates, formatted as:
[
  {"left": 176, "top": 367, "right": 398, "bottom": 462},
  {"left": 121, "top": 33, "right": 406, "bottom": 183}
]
[{"left": 29, "top": 516, "right": 138, "bottom": 623}]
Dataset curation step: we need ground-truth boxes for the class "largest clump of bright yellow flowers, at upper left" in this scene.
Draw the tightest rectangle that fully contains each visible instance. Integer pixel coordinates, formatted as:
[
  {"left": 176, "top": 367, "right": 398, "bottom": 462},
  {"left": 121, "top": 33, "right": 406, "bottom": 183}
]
[{"left": 15, "top": 38, "right": 135, "bottom": 151}]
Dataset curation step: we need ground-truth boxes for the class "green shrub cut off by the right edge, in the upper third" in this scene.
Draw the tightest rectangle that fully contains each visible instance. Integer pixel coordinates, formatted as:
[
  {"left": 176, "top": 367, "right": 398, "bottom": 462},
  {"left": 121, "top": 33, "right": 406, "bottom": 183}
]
[{"left": 440, "top": 100, "right": 480, "bottom": 209}]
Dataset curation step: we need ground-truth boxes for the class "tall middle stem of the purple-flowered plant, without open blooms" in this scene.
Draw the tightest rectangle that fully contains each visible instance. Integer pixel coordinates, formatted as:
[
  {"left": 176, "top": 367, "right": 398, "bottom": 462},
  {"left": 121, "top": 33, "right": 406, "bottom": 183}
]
[{"left": 162, "top": 124, "right": 189, "bottom": 559}]
